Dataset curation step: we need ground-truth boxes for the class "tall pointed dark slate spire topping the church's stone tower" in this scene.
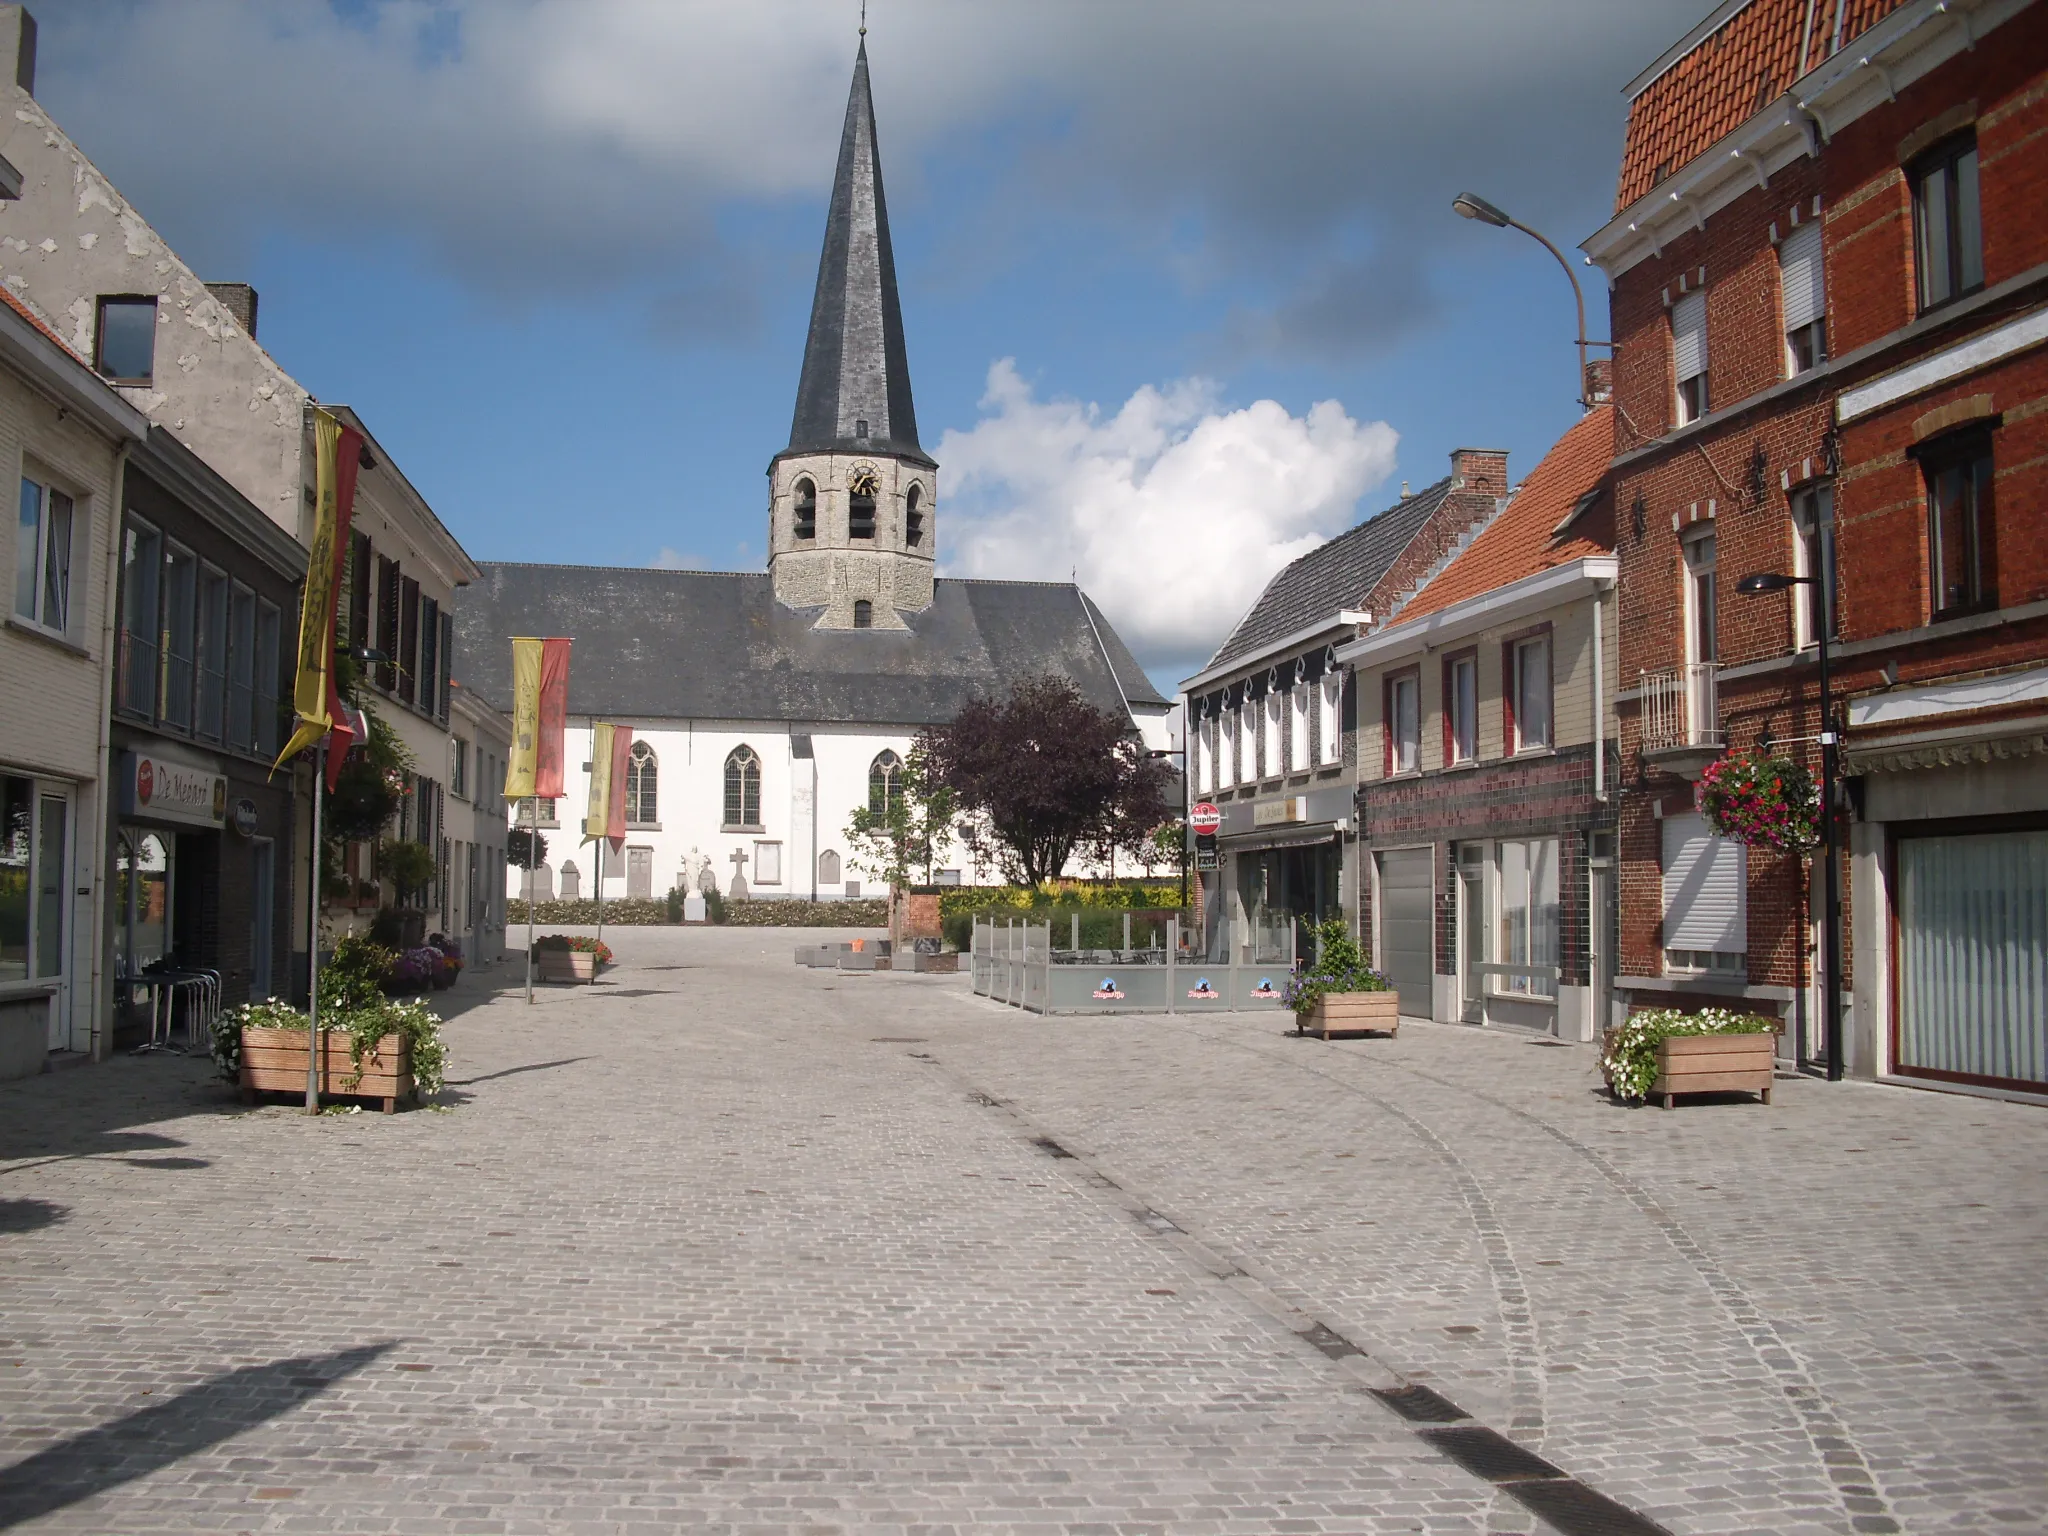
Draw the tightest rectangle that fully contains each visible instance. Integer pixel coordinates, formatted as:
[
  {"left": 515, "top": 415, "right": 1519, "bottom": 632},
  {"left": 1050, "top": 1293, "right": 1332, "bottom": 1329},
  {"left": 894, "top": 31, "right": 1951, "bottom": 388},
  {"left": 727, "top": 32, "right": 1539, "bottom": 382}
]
[{"left": 788, "top": 36, "right": 932, "bottom": 465}]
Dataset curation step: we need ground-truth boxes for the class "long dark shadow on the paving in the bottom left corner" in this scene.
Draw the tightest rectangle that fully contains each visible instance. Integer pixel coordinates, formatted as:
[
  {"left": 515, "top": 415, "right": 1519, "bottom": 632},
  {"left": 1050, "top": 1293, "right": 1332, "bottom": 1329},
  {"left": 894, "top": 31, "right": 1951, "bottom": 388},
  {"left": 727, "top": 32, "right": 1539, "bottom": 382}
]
[{"left": 0, "top": 1339, "right": 395, "bottom": 1530}]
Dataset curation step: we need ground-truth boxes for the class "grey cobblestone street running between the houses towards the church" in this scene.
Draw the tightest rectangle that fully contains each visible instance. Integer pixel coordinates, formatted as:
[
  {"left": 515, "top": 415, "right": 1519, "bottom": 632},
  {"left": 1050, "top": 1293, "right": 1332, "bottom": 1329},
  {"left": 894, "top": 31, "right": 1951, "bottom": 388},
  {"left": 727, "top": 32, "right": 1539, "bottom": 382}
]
[{"left": 0, "top": 930, "right": 2048, "bottom": 1536}]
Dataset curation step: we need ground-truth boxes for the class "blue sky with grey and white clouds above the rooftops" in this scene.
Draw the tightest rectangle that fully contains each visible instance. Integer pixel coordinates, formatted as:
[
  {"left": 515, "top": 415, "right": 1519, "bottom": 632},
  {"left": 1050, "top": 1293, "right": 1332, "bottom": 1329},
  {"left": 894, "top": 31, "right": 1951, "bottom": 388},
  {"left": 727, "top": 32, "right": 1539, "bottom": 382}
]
[{"left": 33, "top": 0, "right": 1704, "bottom": 684}]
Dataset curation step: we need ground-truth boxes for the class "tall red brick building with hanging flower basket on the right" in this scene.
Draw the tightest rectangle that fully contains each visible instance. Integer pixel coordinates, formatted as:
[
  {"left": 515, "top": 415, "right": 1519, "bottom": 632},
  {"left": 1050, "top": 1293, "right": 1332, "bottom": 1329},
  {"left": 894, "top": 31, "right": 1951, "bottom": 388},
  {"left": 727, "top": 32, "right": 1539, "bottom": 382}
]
[{"left": 1583, "top": 0, "right": 2048, "bottom": 1094}]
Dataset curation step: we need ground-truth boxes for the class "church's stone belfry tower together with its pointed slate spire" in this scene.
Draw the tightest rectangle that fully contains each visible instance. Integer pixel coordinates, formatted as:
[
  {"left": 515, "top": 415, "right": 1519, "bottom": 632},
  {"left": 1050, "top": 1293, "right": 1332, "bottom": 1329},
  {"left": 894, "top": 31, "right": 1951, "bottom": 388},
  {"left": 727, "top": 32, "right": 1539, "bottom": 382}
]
[{"left": 768, "top": 40, "right": 938, "bottom": 629}]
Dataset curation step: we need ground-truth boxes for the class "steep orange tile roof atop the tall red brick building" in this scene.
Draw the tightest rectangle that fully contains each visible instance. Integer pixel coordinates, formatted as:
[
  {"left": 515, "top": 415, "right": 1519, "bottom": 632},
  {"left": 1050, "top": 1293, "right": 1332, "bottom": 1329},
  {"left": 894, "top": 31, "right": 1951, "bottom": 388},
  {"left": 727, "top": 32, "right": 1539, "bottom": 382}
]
[{"left": 1614, "top": 0, "right": 1905, "bottom": 213}]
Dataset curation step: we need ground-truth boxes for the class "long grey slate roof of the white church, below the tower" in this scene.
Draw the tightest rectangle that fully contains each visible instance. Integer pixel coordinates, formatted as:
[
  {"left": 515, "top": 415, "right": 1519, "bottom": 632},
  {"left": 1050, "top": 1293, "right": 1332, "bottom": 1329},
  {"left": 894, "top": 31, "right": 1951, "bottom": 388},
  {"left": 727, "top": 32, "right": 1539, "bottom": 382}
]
[{"left": 453, "top": 563, "right": 1167, "bottom": 727}]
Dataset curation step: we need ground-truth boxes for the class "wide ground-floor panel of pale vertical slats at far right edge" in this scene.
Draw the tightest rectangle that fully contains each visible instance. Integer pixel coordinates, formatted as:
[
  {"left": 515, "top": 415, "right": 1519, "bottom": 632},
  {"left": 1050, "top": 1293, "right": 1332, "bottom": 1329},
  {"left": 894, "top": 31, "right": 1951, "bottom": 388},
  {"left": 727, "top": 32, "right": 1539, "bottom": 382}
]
[{"left": 1898, "top": 831, "right": 2048, "bottom": 1087}]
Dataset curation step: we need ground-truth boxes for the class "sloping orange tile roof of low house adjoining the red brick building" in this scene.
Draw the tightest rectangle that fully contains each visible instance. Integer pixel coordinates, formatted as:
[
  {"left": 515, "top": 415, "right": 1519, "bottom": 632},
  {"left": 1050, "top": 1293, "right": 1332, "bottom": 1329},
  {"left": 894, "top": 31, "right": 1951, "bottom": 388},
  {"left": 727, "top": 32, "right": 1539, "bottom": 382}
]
[{"left": 1389, "top": 406, "right": 1614, "bottom": 629}]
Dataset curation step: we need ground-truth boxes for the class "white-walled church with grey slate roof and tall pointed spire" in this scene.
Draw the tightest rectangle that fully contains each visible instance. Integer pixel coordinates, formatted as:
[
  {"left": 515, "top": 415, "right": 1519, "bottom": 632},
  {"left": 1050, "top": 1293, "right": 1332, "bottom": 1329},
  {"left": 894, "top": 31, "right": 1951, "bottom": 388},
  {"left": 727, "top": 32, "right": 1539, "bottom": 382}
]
[{"left": 455, "top": 39, "right": 1171, "bottom": 901}]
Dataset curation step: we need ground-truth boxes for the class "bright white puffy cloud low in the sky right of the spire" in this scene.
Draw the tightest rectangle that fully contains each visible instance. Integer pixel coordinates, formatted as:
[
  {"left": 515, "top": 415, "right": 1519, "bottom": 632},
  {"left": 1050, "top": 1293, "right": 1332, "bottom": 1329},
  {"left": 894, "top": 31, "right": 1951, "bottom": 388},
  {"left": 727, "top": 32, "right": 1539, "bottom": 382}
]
[{"left": 938, "top": 358, "right": 1399, "bottom": 668}]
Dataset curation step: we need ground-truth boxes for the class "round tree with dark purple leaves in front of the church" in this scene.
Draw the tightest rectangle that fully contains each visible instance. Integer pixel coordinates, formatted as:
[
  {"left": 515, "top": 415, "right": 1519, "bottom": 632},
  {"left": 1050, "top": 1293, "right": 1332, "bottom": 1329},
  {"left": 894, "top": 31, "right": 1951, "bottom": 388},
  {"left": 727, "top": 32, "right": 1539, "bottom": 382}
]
[{"left": 920, "top": 676, "right": 1171, "bottom": 887}]
